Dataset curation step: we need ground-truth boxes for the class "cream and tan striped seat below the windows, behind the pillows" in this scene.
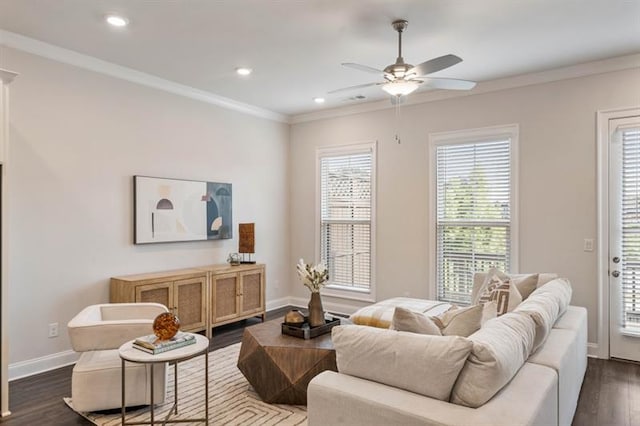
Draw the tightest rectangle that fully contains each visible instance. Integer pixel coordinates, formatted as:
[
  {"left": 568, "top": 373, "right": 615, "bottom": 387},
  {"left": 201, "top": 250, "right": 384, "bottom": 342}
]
[{"left": 349, "top": 297, "right": 451, "bottom": 328}]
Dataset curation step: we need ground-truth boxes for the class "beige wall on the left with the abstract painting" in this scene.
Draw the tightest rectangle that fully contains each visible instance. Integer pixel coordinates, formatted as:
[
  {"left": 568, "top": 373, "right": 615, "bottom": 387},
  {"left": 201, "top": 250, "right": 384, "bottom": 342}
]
[{"left": 0, "top": 48, "right": 290, "bottom": 372}]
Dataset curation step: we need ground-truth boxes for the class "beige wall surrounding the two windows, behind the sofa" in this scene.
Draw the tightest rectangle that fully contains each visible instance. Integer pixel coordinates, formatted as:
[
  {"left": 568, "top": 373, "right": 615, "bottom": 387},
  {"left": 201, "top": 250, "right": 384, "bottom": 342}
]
[{"left": 290, "top": 65, "right": 640, "bottom": 343}]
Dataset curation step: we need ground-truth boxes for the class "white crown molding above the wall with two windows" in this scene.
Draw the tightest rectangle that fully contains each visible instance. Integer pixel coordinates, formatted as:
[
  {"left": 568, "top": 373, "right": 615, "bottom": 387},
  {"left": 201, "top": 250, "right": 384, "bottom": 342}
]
[{"left": 289, "top": 53, "right": 640, "bottom": 124}]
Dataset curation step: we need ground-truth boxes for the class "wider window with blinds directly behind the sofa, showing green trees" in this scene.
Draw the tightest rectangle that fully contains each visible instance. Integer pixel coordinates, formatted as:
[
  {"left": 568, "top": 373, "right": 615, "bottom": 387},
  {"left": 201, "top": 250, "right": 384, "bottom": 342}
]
[{"left": 430, "top": 126, "right": 518, "bottom": 304}]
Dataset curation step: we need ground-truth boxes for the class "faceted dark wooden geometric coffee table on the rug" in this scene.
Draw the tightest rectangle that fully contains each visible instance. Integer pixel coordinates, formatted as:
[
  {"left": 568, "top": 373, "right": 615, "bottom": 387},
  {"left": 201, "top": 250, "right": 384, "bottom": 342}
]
[{"left": 238, "top": 319, "right": 338, "bottom": 405}]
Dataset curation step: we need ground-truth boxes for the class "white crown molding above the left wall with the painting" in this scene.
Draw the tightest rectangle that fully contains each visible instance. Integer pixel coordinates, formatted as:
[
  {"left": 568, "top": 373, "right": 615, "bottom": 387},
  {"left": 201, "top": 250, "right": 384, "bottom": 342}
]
[{"left": 0, "top": 30, "right": 289, "bottom": 123}]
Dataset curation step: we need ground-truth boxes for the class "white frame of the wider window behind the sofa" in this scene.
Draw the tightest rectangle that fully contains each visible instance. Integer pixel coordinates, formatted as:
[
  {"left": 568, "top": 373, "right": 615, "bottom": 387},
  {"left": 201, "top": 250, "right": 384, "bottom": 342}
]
[{"left": 427, "top": 124, "right": 520, "bottom": 300}]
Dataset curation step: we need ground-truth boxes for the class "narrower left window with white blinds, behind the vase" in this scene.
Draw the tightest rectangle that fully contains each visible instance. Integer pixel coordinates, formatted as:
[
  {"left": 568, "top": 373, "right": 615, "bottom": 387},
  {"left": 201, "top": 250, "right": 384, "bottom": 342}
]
[{"left": 318, "top": 144, "right": 375, "bottom": 296}]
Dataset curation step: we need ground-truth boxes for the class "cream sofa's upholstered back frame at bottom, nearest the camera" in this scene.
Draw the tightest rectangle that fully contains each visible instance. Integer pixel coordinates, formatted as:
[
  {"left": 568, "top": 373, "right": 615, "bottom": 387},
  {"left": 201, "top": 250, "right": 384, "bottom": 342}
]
[{"left": 307, "top": 363, "right": 558, "bottom": 426}]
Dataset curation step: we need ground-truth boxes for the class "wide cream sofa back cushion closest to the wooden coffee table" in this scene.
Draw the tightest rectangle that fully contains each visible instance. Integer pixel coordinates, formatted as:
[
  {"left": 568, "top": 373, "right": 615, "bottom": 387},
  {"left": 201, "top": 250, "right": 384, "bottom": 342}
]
[{"left": 331, "top": 325, "right": 472, "bottom": 401}]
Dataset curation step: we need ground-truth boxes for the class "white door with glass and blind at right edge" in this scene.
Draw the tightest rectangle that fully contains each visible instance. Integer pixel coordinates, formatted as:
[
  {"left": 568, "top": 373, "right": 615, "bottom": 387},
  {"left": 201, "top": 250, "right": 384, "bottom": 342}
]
[{"left": 609, "top": 116, "right": 640, "bottom": 361}]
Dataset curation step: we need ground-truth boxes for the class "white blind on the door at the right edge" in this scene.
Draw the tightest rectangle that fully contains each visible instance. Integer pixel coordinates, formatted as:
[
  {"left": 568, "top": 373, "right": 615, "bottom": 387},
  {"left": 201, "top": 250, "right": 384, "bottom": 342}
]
[{"left": 621, "top": 128, "right": 640, "bottom": 334}]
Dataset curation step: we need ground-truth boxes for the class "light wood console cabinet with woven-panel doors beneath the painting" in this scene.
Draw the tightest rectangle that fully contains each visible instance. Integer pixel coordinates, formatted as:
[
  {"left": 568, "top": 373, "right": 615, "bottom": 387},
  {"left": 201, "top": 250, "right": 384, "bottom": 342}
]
[{"left": 109, "top": 264, "right": 265, "bottom": 337}]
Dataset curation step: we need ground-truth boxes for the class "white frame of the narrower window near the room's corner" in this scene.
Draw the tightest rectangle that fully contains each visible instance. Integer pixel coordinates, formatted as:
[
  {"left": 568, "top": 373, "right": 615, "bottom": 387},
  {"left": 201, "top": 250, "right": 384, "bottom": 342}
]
[{"left": 315, "top": 141, "right": 377, "bottom": 302}]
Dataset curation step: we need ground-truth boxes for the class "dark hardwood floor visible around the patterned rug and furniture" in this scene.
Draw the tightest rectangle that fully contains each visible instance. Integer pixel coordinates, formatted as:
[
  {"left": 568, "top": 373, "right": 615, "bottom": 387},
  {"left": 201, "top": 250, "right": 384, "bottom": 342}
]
[{"left": 0, "top": 308, "right": 640, "bottom": 426}]
